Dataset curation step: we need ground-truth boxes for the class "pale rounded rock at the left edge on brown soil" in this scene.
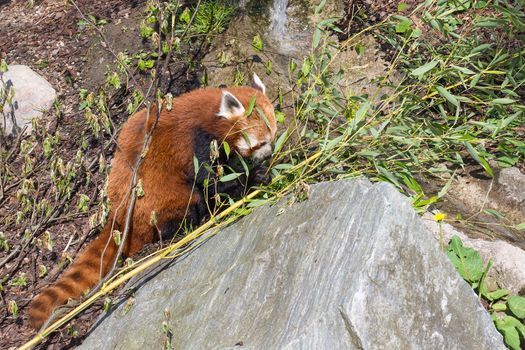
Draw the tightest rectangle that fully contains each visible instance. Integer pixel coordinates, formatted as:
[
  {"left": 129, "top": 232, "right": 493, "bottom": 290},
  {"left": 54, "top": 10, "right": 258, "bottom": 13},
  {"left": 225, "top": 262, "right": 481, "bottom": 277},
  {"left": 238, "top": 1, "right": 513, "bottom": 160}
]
[{"left": 0, "top": 65, "right": 56, "bottom": 135}]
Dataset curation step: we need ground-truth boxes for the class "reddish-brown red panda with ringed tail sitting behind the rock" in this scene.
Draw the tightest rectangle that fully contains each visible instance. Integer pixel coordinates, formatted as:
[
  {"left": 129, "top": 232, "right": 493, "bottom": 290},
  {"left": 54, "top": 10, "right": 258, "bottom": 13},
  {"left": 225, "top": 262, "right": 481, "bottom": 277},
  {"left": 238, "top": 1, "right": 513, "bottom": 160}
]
[{"left": 29, "top": 74, "right": 277, "bottom": 329}]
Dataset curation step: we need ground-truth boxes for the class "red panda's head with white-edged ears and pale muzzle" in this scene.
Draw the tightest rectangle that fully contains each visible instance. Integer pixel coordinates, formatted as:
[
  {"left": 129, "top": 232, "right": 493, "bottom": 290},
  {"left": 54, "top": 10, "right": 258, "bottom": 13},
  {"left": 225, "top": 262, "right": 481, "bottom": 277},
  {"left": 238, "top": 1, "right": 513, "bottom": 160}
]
[{"left": 217, "top": 74, "right": 277, "bottom": 161}]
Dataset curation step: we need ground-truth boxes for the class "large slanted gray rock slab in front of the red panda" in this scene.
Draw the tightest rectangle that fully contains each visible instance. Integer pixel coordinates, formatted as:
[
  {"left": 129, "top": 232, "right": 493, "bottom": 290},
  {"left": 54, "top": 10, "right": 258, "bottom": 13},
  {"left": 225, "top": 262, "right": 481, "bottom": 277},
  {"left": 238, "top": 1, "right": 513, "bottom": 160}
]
[{"left": 80, "top": 180, "right": 504, "bottom": 350}]
